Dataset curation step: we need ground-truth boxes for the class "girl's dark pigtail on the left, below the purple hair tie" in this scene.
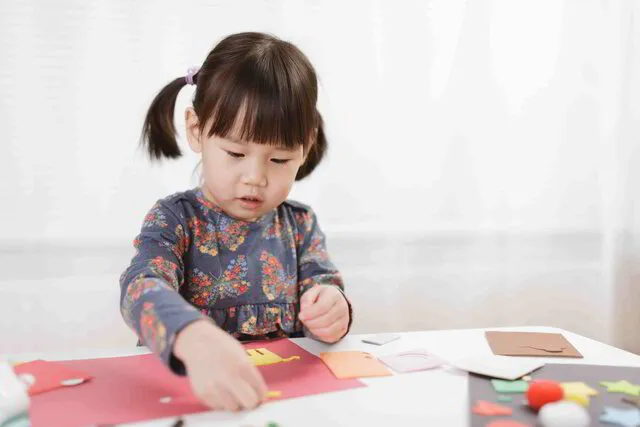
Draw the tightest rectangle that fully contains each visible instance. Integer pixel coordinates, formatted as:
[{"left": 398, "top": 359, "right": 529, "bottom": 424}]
[{"left": 140, "top": 77, "right": 187, "bottom": 160}]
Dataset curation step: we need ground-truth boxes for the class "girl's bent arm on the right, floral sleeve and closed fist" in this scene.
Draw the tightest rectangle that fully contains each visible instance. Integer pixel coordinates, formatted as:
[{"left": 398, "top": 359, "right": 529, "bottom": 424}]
[{"left": 296, "top": 209, "right": 353, "bottom": 342}]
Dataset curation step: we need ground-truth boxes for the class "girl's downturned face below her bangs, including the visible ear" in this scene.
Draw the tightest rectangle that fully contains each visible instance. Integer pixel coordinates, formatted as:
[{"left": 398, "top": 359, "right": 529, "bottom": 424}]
[{"left": 187, "top": 111, "right": 304, "bottom": 221}]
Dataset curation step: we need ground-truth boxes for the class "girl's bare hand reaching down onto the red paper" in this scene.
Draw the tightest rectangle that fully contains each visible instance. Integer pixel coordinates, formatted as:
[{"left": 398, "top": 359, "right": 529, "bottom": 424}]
[{"left": 174, "top": 320, "right": 267, "bottom": 411}]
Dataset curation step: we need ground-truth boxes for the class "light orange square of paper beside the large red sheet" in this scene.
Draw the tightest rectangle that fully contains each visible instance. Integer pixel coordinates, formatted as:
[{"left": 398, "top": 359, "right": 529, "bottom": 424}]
[{"left": 320, "top": 351, "right": 391, "bottom": 379}]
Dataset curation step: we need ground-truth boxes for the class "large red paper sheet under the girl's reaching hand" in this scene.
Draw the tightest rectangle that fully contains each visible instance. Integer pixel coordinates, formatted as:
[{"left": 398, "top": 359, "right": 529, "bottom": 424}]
[{"left": 29, "top": 339, "right": 364, "bottom": 427}]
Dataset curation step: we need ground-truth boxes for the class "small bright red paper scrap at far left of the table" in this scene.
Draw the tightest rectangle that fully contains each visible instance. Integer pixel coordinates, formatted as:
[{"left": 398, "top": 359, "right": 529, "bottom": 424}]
[{"left": 13, "top": 360, "right": 91, "bottom": 396}]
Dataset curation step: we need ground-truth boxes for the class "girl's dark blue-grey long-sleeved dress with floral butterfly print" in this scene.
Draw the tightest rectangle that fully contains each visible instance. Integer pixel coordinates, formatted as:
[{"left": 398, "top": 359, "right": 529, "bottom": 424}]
[{"left": 120, "top": 188, "right": 351, "bottom": 374}]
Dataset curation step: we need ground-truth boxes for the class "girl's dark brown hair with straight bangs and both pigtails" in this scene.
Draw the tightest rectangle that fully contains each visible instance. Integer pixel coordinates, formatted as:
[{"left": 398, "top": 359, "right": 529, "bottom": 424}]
[{"left": 141, "top": 33, "right": 327, "bottom": 180}]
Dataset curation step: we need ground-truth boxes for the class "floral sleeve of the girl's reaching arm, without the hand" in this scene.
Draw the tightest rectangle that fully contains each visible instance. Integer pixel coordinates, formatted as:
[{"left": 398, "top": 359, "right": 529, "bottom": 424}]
[{"left": 120, "top": 199, "right": 204, "bottom": 374}]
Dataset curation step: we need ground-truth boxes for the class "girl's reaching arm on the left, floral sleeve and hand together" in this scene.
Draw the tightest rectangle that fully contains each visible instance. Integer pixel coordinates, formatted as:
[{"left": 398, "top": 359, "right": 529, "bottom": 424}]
[{"left": 120, "top": 199, "right": 267, "bottom": 411}]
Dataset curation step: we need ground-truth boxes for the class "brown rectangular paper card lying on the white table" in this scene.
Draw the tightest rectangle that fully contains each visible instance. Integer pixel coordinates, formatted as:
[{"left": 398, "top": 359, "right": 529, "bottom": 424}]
[{"left": 485, "top": 331, "right": 583, "bottom": 358}]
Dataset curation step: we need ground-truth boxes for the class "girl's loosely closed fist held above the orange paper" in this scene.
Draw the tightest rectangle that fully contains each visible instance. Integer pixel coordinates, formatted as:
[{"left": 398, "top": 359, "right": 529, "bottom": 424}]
[{"left": 298, "top": 285, "right": 349, "bottom": 343}]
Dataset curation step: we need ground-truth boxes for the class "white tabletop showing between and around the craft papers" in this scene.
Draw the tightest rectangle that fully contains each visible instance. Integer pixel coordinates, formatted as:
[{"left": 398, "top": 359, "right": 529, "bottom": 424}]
[{"left": 10, "top": 327, "right": 640, "bottom": 427}]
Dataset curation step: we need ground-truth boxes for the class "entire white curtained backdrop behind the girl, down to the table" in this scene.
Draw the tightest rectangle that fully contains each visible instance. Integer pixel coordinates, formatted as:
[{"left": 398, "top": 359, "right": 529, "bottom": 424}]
[{"left": 0, "top": 0, "right": 640, "bottom": 353}]
